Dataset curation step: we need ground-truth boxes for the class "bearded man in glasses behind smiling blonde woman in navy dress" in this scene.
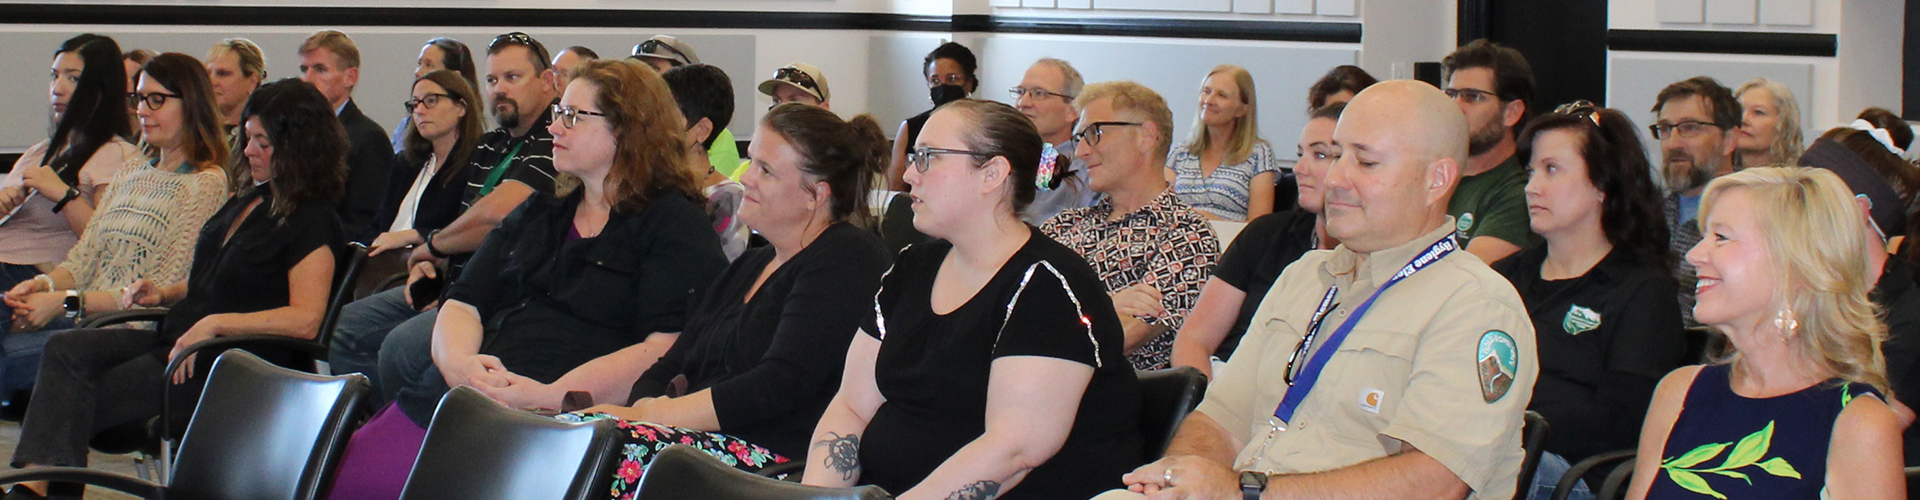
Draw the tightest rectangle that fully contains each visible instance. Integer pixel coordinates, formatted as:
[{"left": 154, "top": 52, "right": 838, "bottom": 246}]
[{"left": 1647, "top": 77, "right": 1741, "bottom": 327}]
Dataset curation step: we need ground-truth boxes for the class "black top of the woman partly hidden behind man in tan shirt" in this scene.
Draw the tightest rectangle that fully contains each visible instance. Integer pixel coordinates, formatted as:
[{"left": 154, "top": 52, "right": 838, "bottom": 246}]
[{"left": 1213, "top": 208, "right": 1319, "bottom": 360}]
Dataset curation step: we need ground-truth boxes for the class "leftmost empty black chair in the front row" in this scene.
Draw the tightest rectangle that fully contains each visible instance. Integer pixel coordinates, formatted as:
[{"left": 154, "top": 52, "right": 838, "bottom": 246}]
[{"left": 0, "top": 350, "right": 372, "bottom": 500}]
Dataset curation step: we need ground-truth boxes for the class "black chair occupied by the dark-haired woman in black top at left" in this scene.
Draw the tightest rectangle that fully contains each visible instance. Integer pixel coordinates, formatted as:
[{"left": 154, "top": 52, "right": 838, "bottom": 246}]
[{"left": 81, "top": 242, "right": 367, "bottom": 481}]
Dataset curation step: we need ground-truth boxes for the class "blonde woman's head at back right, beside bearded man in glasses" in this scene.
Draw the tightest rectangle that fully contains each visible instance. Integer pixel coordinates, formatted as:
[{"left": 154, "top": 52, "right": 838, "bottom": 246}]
[{"left": 1734, "top": 79, "right": 1807, "bottom": 167}]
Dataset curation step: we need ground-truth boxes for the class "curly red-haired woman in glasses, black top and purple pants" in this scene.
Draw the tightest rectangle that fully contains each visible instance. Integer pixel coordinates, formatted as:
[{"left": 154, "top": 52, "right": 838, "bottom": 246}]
[{"left": 330, "top": 60, "right": 728, "bottom": 498}]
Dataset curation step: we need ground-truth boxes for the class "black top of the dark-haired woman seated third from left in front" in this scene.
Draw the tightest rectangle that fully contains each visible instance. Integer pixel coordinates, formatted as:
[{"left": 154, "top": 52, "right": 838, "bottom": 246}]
[{"left": 156, "top": 185, "right": 346, "bottom": 358}]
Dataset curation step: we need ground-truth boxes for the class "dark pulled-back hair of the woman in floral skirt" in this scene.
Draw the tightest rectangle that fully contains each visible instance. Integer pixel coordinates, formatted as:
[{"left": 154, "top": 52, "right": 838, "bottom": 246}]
[{"left": 760, "top": 103, "right": 893, "bottom": 227}]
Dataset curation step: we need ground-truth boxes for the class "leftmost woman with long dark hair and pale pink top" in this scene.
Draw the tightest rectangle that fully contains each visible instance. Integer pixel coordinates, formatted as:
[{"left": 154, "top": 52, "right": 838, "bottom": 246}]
[{"left": 0, "top": 35, "right": 146, "bottom": 336}]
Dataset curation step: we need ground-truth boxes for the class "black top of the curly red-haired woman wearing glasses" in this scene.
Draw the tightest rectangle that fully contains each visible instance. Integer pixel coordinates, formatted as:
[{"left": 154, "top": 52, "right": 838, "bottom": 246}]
[{"left": 447, "top": 190, "right": 726, "bottom": 383}]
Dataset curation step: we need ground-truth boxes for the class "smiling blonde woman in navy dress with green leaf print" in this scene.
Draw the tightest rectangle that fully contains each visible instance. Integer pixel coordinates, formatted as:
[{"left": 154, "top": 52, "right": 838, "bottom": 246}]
[{"left": 1628, "top": 167, "right": 1907, "bottom": 500}]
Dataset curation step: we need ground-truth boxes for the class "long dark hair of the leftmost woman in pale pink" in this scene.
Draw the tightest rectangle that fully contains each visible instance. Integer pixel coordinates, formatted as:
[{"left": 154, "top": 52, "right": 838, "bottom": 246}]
[{"left": 40, "top": 35, "right": 132, "bottom": 189}]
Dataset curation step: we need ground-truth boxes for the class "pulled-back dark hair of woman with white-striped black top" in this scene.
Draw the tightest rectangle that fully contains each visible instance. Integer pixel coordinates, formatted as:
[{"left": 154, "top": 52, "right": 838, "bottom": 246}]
[{"left": 935, "top": 98, "right": 1046, "bottom": 213}]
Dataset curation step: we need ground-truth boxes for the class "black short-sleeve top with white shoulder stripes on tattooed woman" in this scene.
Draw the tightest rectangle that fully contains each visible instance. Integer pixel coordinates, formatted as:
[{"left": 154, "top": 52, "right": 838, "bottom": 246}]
[{"left": 860, "top": 227, "right": 1140, "bottom": 498}]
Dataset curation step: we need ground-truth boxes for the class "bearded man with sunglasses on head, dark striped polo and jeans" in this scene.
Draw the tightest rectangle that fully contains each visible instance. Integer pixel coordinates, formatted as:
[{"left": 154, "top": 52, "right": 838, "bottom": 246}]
[{"left": 328, "top": 31, "right": 561, "bottom": 398}]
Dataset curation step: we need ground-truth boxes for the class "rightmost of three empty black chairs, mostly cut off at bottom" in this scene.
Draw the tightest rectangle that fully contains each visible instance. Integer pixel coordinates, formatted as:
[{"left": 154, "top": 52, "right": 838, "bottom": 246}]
[{"left": 634, "top": 444, "right": 893, "bottom": 500}]
